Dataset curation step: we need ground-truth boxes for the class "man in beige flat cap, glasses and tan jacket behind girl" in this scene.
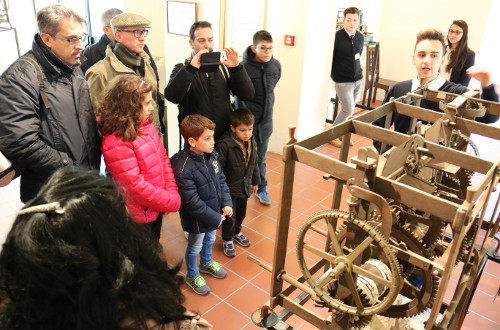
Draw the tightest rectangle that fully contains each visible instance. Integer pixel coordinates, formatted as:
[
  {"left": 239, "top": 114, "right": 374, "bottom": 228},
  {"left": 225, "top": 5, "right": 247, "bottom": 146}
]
[{"left": 85, "top": 13, "right": 163, "bottom": 133}]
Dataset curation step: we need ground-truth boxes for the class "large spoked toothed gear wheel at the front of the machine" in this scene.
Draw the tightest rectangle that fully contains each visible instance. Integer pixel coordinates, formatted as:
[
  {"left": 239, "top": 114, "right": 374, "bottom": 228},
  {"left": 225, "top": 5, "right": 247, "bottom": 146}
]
[{"left": 297, "top": 210, "right": 402, "bottom": 316}]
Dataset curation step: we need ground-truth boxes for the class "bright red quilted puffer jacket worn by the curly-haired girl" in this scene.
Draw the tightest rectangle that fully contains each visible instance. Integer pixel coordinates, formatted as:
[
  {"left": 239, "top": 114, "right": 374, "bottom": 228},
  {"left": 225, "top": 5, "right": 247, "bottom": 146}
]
[{"left": 101, "top": 120, "right": 181, "bottom": 223}]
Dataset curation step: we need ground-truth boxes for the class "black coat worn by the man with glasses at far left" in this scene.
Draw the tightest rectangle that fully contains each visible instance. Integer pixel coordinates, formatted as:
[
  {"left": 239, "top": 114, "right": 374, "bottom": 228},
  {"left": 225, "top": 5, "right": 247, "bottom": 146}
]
[{"left": 0, "top": 34, "right": 101, "bottom": 202}]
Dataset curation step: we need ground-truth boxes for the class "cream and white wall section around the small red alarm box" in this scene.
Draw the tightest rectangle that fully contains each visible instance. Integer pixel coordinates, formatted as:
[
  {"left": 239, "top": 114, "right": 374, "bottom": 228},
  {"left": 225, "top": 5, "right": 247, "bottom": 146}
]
[{"left": 267, "top": 0, "right": 338, "bottom": 153}]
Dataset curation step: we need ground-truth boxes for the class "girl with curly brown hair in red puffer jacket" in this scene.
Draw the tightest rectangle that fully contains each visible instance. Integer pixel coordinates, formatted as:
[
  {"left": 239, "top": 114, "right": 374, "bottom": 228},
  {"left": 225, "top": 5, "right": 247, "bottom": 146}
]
[{"left": 99, "top": 75, "right": 181, "bottom": 240}]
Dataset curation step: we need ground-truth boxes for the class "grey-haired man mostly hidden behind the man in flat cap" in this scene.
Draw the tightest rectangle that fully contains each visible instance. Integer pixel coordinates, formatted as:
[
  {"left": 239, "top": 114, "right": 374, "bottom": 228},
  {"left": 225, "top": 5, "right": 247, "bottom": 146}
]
[{"left": 80, "top": 8, "right": 160, "bottom": 81}]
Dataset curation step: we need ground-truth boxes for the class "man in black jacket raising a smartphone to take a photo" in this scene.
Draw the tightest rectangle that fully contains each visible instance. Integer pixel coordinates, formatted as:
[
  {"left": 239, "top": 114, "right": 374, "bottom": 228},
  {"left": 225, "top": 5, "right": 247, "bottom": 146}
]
[{"left": 165, "top": 21, "right": 255, "bottom": 142}]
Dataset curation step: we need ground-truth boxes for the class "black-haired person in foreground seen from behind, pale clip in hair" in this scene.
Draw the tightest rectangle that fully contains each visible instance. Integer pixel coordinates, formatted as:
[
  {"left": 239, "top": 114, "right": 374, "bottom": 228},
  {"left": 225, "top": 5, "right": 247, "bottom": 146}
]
[{"left": 0, "top": 168, "right": 211, "bottom": 330}]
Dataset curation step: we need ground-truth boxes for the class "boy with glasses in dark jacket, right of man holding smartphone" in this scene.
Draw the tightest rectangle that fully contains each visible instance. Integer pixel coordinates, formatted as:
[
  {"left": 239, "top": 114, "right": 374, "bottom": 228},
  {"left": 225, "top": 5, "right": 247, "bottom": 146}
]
[{"left": 235, "top": 30, "right": 281, "bottom": 205}]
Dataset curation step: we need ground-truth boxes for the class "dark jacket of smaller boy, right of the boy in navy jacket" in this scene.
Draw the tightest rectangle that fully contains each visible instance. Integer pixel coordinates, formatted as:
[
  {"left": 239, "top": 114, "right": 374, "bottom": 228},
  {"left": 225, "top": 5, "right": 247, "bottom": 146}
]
[{"left": 217, "top": 134, "right": 260, "bottom": 198}]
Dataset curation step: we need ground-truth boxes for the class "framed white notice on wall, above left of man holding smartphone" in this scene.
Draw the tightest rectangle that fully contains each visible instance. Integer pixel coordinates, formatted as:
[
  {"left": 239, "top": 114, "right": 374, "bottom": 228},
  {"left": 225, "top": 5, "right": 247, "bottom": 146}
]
[{"left": 167, "top": 1, "right": 197, "bottom": 36}]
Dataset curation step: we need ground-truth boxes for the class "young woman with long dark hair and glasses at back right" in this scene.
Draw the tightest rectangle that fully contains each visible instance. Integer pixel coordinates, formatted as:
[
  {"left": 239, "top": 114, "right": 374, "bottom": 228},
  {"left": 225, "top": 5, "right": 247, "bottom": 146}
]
[{"left": 441, "top": 20, "right": 476, "bottom": 86}]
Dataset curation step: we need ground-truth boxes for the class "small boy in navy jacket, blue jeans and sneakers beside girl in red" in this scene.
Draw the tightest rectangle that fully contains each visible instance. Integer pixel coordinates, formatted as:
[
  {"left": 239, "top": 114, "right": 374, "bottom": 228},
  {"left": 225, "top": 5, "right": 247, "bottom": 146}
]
[{"left": 171, "top": 115, "right": 233, "bottom": 295}]
